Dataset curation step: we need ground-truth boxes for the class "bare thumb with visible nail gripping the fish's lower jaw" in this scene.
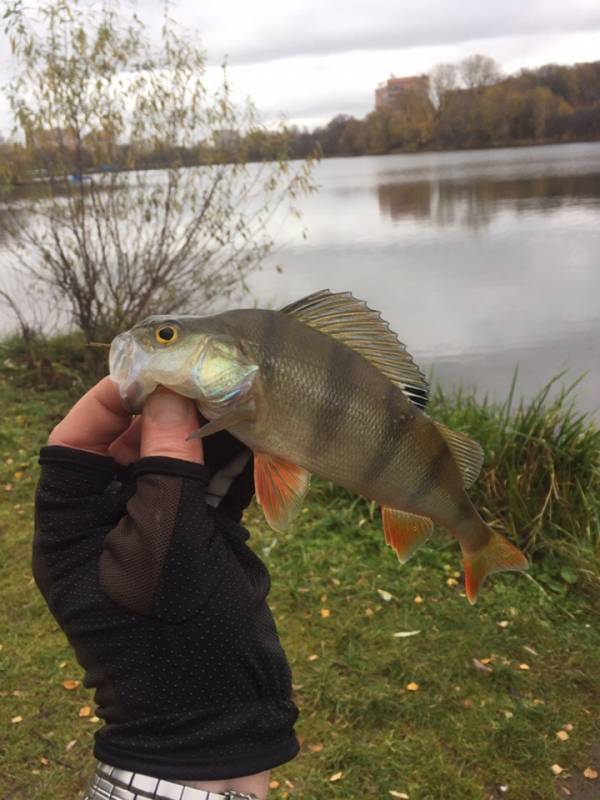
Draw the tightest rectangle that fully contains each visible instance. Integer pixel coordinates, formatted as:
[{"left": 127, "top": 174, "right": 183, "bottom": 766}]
[{"left": 140, "top": 386, "right": 204, "bottom": 464}]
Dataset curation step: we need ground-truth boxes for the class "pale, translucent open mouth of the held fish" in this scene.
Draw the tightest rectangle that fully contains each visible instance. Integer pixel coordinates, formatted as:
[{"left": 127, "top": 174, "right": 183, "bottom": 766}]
[{"left": 108, "top": 331, "right": 158, "bottom": 414}]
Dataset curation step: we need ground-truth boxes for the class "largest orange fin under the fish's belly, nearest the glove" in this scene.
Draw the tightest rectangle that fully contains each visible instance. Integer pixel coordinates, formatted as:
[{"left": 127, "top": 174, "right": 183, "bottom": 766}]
[{"left": 254, "top": 453, "right": 310, "bottom": 531}]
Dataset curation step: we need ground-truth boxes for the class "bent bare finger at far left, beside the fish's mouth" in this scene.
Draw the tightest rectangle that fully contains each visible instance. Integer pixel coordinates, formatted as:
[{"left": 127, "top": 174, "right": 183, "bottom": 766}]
[{"left": 48, "top": 377, "right": 131, "bottom": 453}]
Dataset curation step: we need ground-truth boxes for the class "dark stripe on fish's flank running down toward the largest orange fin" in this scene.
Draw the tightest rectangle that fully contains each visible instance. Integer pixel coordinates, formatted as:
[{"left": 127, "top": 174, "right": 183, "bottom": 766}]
[{"left": 309, "top": 339, "right": 356, "bottom": 456}]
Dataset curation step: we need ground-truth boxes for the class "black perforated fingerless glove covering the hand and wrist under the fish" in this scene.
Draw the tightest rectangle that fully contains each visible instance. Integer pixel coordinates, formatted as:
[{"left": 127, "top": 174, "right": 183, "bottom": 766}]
[{"left": 34, "top": 440, "right": 298, "bottom": 780}]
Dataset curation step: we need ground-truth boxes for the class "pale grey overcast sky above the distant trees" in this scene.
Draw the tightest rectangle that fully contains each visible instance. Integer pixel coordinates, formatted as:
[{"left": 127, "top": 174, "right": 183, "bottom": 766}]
[{"left": 0, "top": 0, "right": 600, "bottom": 134}]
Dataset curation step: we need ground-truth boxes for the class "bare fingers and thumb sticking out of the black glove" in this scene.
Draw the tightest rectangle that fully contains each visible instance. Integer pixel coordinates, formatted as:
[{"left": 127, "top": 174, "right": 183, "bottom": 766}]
[{"left": 48, "top": 378, "right": 204, "bottom": 465}]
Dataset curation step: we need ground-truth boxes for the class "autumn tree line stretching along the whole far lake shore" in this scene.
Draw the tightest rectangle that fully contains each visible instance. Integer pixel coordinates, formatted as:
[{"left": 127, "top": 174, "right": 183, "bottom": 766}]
[{"left": 0, "top": 54, "right": 600, "bottom": 188}]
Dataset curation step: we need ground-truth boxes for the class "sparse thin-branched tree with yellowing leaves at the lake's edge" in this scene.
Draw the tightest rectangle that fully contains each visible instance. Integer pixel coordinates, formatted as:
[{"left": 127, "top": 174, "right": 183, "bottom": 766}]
[{"left": 4, "top": 0, "right": 312, "bottom": 338}]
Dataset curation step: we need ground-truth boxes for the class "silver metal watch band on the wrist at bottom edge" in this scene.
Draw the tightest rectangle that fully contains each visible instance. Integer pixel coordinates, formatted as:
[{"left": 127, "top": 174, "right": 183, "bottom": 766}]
[{"left": 82, "top": 761, "right": 256, "bottom": 800}]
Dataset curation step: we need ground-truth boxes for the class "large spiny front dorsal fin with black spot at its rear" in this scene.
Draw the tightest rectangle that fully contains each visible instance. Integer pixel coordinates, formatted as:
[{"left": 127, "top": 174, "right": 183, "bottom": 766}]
[{"left": 281, "top": 289, "right": 429, "bottom": 408}]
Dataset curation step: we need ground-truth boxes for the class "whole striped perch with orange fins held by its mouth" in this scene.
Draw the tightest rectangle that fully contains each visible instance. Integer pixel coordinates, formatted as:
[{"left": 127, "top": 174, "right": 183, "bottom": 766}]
[{"left": 109, "top": 289, "right": 528, "bottom": 603}]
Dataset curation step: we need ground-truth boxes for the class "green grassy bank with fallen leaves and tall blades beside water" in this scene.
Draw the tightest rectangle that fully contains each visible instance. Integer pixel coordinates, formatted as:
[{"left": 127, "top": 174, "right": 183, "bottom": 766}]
[{"left": 0, "top": 340, "right": 600, "bottom": 800}]
